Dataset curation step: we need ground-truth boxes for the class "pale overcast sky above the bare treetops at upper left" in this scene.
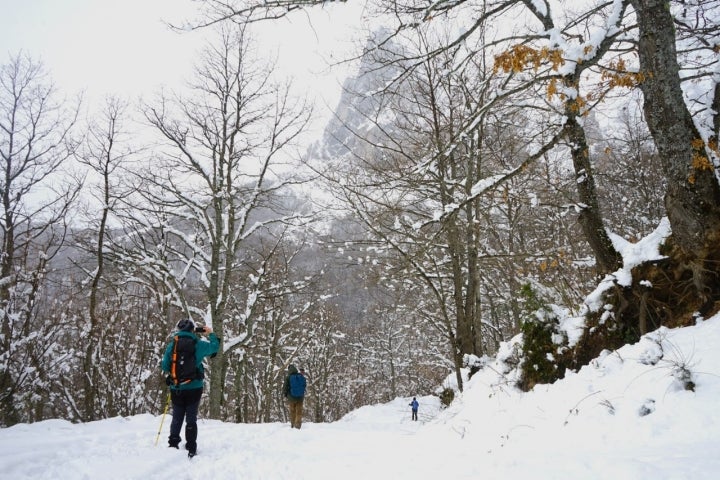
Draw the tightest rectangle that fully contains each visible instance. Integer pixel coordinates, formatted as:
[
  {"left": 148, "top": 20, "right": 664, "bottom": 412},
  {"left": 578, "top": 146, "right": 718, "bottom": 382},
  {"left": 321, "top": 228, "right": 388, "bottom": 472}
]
[{"left": 0, "top": 0, "right": 362, "bottom": 119}]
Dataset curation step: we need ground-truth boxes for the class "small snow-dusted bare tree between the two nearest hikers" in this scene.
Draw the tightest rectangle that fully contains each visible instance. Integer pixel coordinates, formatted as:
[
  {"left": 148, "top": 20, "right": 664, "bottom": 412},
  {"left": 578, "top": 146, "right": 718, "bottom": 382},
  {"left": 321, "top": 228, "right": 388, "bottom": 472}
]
[{"left": 226, "top": 230, "right": 320, "bottom": 422}]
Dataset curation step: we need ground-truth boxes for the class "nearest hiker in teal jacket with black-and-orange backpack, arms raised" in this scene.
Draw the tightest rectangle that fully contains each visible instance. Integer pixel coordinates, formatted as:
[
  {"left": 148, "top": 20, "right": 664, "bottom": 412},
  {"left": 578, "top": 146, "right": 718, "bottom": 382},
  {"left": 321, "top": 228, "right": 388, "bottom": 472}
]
[{"left": 162, "top": 319, "right": 220, "bottom": 458}]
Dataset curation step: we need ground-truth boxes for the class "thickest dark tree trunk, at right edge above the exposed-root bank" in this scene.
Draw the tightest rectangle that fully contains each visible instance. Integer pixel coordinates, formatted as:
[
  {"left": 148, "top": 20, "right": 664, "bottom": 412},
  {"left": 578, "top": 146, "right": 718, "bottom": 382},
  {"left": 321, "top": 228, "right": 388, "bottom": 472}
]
[{"left": 631, "top": 0, "right": 720, "bottom": 297}]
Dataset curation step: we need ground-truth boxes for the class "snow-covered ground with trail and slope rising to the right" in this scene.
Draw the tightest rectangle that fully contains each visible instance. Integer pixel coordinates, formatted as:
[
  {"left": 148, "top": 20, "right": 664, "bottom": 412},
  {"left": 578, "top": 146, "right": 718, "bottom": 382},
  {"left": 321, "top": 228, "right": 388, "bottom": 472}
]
[{"left": 0, "top": 316, "right": 720, "bottom": 480}]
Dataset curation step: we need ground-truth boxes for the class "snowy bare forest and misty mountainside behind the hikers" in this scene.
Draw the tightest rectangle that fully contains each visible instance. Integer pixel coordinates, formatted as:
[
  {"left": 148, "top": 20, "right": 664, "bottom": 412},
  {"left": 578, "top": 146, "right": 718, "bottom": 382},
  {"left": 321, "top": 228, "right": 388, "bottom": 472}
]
[{"left": 0, "top": 0, "right": 720, "bottom": 426}]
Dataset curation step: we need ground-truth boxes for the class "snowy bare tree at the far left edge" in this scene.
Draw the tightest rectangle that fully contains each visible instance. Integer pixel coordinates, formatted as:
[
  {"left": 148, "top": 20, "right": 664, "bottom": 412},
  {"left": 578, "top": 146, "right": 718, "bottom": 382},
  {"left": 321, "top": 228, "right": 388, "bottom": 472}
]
[{"left": 0, "top": 55, "right": 80, "bottom": 425}]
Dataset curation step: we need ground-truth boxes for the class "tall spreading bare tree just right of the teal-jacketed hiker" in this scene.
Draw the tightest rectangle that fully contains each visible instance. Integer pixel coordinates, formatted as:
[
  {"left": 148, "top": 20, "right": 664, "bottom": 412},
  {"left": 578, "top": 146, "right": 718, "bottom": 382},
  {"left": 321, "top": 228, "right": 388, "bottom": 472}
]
[{"left": 114, "top": 26, "right": 311, "bottom": 418}]
